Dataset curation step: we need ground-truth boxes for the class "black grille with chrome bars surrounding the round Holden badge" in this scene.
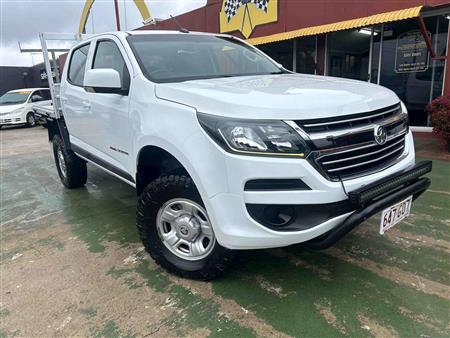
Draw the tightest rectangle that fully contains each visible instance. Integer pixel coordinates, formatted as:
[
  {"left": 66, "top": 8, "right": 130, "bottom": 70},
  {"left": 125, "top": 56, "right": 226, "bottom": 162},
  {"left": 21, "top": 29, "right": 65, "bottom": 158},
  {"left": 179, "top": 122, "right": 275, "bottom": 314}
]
[{"left": 295, "top": 104, "right": 408, "bottom": 181}]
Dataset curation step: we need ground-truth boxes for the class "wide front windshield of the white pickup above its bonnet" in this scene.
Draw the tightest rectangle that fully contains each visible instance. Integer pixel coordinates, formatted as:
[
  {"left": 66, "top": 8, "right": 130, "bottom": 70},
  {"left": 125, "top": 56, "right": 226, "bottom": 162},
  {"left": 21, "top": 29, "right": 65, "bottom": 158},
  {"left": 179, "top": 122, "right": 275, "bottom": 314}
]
[{"left": 127, "top": 34, "right": 284, "bottom": 82}]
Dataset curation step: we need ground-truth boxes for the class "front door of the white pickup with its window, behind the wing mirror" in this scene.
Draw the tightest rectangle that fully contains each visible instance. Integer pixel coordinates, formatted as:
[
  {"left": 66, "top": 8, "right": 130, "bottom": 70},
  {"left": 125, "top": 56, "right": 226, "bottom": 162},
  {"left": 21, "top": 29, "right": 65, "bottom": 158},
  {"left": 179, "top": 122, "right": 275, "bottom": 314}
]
[{"left": 86, "top": 36, "right": 132, "bottom": 171}]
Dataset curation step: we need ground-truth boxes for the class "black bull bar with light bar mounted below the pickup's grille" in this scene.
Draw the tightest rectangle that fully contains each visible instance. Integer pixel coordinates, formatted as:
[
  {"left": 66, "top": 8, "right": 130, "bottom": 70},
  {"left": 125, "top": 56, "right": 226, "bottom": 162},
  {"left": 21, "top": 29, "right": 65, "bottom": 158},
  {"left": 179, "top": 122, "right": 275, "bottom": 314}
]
[{"left": 305, "top": 161, "right": 432, "bottom": 249}]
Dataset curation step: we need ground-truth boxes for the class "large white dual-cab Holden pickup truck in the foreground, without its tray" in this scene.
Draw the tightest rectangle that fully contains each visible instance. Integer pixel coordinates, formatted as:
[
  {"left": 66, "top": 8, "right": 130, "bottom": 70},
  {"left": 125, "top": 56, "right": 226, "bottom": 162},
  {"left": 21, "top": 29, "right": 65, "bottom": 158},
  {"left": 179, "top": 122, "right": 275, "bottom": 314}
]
[{"left": 48, "top": 31, "right": 431, "bottom": 280}]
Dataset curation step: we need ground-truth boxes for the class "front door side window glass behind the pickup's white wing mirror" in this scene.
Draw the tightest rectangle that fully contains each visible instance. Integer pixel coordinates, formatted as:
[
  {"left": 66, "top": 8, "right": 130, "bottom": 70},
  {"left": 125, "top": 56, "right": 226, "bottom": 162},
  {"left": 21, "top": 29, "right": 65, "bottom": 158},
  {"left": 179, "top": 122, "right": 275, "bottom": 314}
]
[{"left": 92, "top": 40, "right": 130, "bottom": 90}]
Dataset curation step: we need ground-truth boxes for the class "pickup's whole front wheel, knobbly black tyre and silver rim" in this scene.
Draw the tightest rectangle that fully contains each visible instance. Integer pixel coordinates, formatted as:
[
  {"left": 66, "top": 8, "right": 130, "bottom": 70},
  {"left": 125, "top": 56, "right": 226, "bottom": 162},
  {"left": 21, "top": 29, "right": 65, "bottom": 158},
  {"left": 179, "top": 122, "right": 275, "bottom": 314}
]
[{"left": 137, "top": 175, "right": 234, "bottom": 280}]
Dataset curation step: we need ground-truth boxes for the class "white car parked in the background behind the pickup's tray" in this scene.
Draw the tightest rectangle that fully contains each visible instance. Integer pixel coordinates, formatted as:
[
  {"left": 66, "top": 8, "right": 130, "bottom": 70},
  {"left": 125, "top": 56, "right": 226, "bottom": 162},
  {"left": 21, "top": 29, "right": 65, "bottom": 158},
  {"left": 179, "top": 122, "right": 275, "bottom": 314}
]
[{"left": 0, "top": 88, "right": 51, "bottom": 128}]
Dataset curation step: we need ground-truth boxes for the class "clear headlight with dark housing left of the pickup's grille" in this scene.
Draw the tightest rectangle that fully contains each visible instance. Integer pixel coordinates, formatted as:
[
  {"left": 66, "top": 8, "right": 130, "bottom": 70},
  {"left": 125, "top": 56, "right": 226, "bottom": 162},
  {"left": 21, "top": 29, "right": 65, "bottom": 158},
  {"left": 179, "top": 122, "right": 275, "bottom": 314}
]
[{"left": 197, "top": 113, "right": 308, "bottom": 158}]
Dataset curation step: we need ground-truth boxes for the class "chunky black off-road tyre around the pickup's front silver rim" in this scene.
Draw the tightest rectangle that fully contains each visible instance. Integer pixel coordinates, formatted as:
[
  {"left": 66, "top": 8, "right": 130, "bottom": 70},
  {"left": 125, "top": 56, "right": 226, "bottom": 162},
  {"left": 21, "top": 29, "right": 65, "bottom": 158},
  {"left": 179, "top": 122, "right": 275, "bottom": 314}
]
[{"left": 136, "top": 175, "right": 235, "bottom": 281}]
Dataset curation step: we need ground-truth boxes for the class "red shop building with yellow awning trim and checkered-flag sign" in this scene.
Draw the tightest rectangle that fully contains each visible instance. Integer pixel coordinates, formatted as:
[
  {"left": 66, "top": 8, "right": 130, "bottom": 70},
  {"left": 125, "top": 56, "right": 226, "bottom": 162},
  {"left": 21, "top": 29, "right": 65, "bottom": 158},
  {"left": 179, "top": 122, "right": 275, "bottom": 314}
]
[{"left": 140, "top": 0, "right": 450, "bottom": 126}]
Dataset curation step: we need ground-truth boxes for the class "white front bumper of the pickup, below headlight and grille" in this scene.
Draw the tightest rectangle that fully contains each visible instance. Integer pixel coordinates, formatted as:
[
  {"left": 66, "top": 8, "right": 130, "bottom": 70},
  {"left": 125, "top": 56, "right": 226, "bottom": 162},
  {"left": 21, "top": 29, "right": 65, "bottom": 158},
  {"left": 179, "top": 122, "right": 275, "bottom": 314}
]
[{"left": 204, "top": 133, "right": 426, "bottom": 249}]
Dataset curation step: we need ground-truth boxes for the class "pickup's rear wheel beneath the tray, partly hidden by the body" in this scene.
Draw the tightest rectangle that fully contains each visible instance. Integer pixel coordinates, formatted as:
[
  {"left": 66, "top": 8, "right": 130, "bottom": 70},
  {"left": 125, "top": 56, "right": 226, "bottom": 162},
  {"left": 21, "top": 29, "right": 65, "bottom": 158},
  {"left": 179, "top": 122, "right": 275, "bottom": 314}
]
[{"left": 53, "top": 135, "right": 87, "bottom": 189}]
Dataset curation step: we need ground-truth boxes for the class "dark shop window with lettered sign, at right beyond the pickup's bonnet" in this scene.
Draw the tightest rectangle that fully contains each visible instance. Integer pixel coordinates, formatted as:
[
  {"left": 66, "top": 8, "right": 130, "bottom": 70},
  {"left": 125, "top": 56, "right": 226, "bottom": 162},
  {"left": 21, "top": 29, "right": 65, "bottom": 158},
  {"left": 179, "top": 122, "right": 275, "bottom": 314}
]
[{"left": 379, "top": 16, "right": 448, "bottom": 126}]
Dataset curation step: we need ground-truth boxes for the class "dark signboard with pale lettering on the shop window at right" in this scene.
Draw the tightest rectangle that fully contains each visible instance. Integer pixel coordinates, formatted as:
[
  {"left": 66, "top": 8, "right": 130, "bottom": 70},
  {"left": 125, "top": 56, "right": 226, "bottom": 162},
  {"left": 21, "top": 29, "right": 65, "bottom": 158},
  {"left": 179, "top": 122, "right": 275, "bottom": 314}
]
[{"left": 395, "top": 31, "right": 429, "bottom": 73}]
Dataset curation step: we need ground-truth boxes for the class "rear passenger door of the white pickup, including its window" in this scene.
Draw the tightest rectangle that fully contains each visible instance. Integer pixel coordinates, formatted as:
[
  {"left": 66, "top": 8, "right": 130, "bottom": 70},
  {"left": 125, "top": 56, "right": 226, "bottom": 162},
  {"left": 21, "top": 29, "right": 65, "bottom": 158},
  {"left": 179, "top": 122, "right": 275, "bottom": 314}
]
[{"left": 61, "top": 42, "right": 95, "bottom": 146}]
